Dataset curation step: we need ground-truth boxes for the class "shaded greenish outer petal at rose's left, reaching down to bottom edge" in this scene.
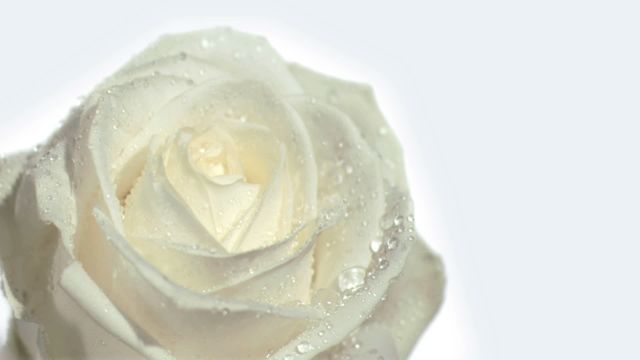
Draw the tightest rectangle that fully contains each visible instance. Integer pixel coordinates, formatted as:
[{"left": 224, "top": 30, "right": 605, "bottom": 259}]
[{"left": 0, "top": 146, "right": 171, "bottom": 358}]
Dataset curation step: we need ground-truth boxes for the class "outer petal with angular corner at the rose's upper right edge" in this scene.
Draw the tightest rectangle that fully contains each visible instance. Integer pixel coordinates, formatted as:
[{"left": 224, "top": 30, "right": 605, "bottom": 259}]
[{"left": 289, "top": 64, "right": 407, "bottom": 189}]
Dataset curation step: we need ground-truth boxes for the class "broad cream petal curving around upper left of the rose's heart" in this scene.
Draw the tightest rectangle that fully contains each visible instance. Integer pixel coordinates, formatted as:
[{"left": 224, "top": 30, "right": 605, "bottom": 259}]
[{"left": 85, "top": 76, "right": 195, "bottom": 233}]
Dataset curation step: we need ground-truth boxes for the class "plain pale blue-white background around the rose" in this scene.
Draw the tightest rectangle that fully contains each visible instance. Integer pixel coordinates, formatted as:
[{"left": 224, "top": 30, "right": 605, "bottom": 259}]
[{"left": 0, "top": 0, "right": 640, "bottom": 360}]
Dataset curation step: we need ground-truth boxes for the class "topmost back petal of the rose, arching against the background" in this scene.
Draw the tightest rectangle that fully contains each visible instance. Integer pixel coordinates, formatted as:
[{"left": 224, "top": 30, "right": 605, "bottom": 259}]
[{"left": 112, "top": 28, "right": 301, "bottom": 94}]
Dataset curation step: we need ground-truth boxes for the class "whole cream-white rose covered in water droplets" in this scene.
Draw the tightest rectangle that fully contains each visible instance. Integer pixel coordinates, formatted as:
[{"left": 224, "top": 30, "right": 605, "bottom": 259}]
[{"left": 0, "top": 29, "right": 443, "bottom": 359}]
